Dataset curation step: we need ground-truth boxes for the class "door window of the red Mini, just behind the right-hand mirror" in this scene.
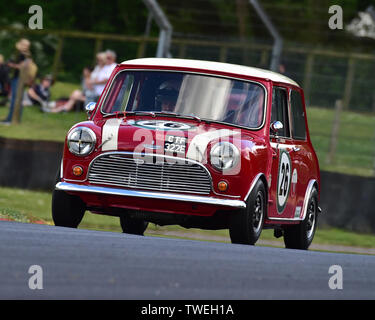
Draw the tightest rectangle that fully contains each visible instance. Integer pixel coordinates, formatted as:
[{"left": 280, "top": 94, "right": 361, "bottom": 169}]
[{"left": 271, "top": 87, "right": 290, "bottom": 137}]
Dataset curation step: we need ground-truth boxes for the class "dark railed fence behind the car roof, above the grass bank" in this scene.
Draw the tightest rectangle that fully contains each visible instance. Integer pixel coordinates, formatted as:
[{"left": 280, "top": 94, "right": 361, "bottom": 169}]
[{"left": 0, "top": 28, "right": 375, "bottom": 112}]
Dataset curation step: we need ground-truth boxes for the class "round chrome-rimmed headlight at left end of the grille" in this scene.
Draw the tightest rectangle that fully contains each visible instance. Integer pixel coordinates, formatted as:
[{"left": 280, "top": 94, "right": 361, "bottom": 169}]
[{"left": 68, "top": 127, "right": 96, "bottom": 156}]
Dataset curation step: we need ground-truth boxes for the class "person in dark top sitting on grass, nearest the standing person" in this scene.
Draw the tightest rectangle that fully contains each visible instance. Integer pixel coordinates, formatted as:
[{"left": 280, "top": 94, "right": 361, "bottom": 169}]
[{"left": 22, "top": 75, "right": 54, "bottom": 110}]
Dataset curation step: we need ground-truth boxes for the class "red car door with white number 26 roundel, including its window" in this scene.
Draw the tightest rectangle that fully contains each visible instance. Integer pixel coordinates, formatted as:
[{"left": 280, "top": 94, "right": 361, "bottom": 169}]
[{"left": 268, "top": 86, "right": 297, "bottom": 220}]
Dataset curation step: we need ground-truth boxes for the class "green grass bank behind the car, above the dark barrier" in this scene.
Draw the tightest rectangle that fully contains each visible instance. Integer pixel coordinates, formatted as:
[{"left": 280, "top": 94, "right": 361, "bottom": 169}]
[{"left": 0, "top": 82, "right": 375, "bottom": 176}]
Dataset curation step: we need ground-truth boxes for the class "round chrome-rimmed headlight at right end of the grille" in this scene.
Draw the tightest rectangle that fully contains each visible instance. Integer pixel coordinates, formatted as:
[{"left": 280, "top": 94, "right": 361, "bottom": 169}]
[{"left": 210, "top": 141, "right": 240, "bottom": 170}]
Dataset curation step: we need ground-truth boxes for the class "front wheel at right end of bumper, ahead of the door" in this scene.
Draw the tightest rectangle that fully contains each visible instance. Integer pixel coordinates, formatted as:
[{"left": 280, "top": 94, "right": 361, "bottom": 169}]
[{"left": 229, "top": 180, "right": 267, "bottom": 245}]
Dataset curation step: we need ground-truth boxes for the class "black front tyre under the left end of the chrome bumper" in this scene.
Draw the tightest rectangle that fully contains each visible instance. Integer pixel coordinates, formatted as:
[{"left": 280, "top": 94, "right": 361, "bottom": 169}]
[{"left": 52, "top": 170, "right": 86, "bottom": 228}]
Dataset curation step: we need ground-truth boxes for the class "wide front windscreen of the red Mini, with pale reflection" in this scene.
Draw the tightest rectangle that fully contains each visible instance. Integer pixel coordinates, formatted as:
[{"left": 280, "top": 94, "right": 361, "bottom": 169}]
[{"left": 102, "top": 71, "right": 265, "bottom": 128}]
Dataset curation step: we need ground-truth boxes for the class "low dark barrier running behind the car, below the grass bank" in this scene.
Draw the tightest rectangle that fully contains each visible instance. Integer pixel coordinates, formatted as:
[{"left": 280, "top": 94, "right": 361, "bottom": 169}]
[{"left": 0, "top": 138, "right": 375, "bottom": 233}]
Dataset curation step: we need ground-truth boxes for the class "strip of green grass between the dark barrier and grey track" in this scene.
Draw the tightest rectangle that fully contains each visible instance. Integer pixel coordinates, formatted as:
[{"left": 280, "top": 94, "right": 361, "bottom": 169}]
[{"left": 0, "top": 188, "right": 375, "bottom": 248}]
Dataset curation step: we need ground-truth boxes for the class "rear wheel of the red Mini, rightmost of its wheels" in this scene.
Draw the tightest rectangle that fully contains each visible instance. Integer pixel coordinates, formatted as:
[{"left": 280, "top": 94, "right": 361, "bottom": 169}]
[{"left": 284, "top": 189, "right": 318, "bottom": 250}]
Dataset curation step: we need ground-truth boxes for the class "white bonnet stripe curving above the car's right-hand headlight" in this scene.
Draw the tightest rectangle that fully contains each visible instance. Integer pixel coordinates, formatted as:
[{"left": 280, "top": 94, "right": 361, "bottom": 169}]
[{"left": 186, "top": 129, "right": 239, "bottom": 162}]
